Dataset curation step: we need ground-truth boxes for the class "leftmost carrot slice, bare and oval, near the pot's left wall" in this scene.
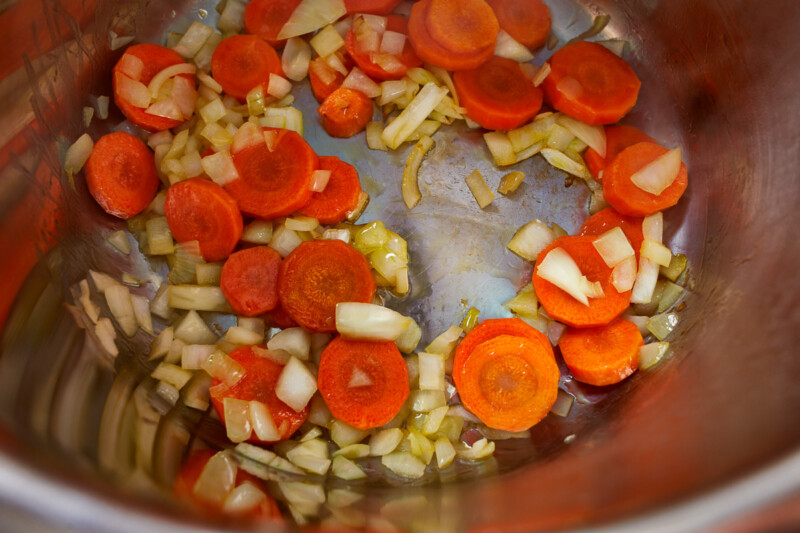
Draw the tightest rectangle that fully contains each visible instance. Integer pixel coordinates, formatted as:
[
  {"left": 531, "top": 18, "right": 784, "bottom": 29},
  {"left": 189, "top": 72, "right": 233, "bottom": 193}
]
[{"left": 86, "top": 131, "right": 161, "bottom": 219}]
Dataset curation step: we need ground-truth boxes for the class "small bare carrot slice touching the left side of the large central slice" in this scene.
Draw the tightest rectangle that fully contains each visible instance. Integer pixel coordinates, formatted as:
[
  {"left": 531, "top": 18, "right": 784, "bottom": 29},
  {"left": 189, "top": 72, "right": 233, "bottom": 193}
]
[{"left": 219, "top": 246, "right": 281, "bottom": 316}]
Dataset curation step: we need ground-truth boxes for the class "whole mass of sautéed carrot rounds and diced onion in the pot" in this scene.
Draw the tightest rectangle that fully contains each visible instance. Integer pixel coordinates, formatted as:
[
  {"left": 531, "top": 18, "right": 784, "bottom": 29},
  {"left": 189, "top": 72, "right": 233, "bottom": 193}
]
[{"left": 61, "top": 0, "right": 688, "bottom": 522}]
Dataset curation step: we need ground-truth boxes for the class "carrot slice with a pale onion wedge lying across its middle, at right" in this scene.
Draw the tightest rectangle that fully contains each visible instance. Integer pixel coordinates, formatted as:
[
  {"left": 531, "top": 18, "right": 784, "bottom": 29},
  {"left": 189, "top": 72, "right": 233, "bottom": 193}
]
[{"left": 533, "top": 235, "right": 631, "bottom": 328}]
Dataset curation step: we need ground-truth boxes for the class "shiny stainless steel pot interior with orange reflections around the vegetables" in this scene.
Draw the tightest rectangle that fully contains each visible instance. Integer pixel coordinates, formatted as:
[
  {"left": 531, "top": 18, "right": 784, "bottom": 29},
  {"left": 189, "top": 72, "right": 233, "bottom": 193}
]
[{"left": 0, "top": 0, "right": 800, "bottom": 531}]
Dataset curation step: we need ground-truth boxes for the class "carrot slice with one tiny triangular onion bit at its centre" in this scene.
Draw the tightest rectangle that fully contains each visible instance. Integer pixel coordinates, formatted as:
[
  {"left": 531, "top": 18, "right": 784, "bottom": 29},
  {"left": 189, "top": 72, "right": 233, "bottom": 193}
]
[{"left": 317, "top": 337, "right": 409, "bottom": 429}]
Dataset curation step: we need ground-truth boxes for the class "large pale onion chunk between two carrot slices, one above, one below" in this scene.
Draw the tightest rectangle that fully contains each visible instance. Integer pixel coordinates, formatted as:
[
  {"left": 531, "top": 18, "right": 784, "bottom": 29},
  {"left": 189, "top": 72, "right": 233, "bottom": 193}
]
[{"left": 336, "top": 302, "right": 413, "bottom": 341}]
